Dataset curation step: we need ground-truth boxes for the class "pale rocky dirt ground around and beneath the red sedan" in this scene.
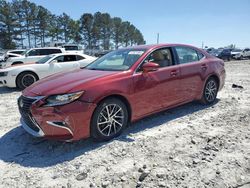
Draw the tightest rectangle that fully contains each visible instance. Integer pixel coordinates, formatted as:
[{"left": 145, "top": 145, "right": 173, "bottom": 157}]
[{"left": 0, "top": 61, "right": 250, "bottom": 188}]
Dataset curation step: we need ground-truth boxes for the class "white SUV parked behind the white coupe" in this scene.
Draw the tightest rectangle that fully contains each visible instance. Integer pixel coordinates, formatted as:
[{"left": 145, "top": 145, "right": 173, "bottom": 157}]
[{"left": 1, "top": 47, "right": 65, "bottom": 68}]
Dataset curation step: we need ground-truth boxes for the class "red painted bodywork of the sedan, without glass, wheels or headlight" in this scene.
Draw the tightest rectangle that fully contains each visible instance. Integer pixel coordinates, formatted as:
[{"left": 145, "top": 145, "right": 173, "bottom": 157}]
[{"left": 20, "top": 44, "right": 225, "bottom": 140}]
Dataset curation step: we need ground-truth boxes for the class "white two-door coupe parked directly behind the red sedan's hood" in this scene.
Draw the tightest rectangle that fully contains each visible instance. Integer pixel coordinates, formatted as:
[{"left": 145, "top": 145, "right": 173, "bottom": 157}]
[{"left": 0, "top": 53, "right": 96, "bottom": 89}]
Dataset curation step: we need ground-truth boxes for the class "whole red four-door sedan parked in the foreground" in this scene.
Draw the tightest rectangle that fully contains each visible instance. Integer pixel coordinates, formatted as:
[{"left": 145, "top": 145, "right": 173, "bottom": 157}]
[{"left": 18, "top": 44, "right": 225, "bottom": 141}]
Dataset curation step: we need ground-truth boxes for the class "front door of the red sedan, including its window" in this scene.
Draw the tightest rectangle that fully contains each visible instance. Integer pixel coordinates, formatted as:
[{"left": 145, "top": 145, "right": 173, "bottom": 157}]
[{"left": 133, "top": 48, "right": 180, "bottom": 117}]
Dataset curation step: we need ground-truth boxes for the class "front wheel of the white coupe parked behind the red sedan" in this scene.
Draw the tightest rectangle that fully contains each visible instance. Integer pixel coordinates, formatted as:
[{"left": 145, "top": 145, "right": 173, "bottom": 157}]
[{"left": 16, "top": 72, "right": 38, "bottom": 90}]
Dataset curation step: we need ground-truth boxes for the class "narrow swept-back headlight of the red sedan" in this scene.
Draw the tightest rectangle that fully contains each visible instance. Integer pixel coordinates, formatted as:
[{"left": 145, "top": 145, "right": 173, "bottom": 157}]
[{"left": 44, "top": 91, "right": 84, "bottom": 106}]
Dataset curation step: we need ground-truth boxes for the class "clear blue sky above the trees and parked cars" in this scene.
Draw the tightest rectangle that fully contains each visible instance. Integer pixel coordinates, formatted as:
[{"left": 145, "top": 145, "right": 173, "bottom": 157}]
[{"left": 30, "top": 0, "right": 250, "bottom": 48}]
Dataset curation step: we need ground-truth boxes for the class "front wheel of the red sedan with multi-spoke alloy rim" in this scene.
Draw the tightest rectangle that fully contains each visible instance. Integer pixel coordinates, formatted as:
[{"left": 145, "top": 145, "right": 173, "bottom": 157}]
[{"left": 91, "top": 98, "right": 128, "bottom": 141}]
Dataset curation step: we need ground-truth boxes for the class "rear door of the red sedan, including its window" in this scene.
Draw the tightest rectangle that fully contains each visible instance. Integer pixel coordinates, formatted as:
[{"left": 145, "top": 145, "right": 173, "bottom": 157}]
[{"left": 175, "top": 46, "right": 208, "bottom": 102}]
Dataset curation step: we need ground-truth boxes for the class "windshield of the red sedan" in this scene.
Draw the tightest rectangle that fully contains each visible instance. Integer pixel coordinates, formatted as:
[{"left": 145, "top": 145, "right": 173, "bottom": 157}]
[{"left": 86, "top": 49, "right": 146, "bottom": 71}]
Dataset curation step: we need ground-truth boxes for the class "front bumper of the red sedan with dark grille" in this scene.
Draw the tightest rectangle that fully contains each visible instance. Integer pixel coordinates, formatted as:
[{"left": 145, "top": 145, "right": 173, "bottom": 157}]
[{"left": 18, "top": 96, "right": 96, "bottom": 141}]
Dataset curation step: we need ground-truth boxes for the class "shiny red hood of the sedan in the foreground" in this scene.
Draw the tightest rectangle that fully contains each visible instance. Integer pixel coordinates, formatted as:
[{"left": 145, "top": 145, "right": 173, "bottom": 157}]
[{"left": 23, "top": 69, "right": 119, "bottom": 97}]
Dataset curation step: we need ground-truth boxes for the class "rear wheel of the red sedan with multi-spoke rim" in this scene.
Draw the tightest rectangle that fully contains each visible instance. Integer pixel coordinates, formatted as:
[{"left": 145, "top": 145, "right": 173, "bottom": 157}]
[{"left": 201, "top": 78, "right": 219, "bottom": 104}]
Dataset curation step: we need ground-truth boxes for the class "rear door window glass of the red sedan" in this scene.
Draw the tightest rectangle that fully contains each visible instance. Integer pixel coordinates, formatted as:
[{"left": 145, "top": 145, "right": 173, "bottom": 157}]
[{"left": 175, "top": 47, "right": 199, "bottom": 64}]
